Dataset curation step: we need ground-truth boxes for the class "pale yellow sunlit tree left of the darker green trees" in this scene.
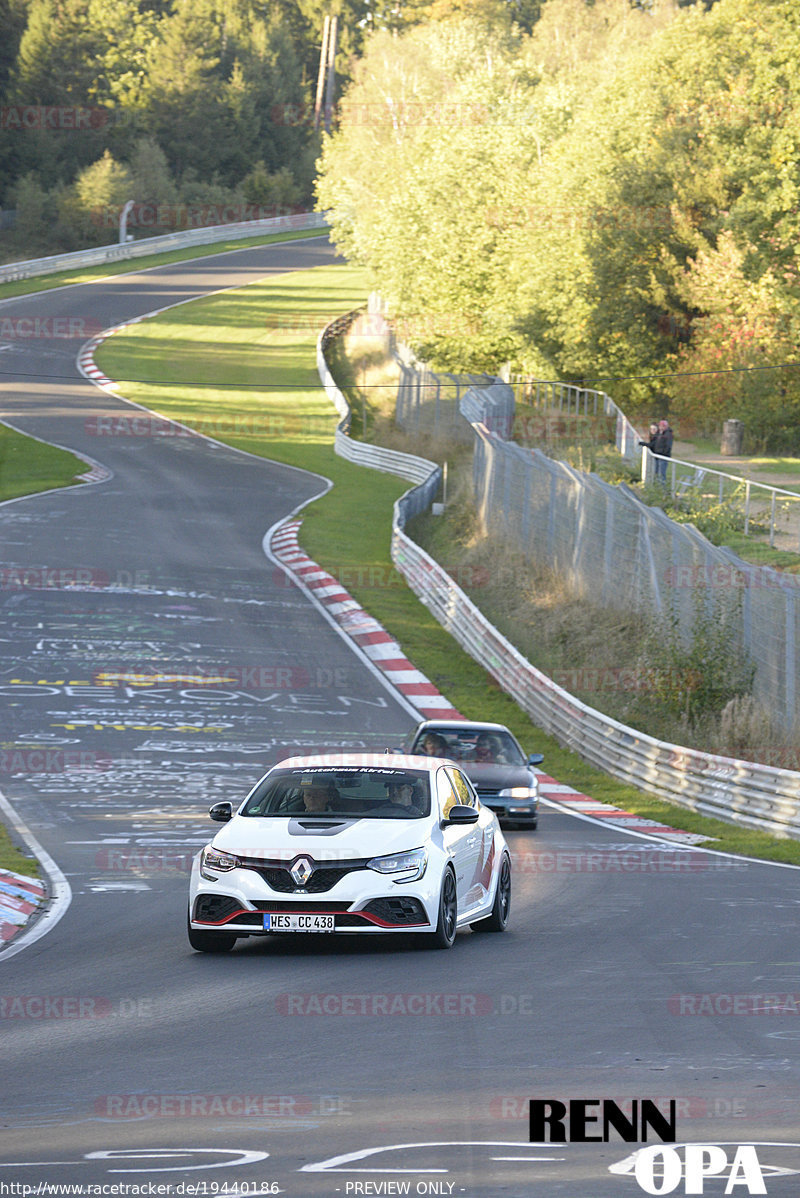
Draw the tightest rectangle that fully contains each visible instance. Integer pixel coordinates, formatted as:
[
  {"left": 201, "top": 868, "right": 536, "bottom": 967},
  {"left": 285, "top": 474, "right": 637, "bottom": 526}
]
[{"left": 317, "top": 20, "right": 537, "bottom": 361}]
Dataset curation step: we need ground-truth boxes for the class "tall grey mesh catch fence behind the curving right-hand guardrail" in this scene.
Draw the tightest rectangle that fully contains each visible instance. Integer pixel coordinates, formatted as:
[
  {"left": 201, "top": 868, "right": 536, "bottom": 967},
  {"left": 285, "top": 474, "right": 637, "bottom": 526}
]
[{"left": 396, "top": 364, "right": 800, "bottom": 734}]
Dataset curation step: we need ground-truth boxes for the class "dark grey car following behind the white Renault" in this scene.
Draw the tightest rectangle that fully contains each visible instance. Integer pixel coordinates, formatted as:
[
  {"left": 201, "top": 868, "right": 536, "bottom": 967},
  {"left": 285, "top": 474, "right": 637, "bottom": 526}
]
[{"left": 402, "top": 720, "right": 543, "bottom": 828}]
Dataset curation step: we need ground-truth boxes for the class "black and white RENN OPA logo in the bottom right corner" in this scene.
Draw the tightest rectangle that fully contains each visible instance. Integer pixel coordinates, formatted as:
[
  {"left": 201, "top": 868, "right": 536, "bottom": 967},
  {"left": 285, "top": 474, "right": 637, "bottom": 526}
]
[{"left": 529, "top": 1099, "right": 766, "bottom": 1194}]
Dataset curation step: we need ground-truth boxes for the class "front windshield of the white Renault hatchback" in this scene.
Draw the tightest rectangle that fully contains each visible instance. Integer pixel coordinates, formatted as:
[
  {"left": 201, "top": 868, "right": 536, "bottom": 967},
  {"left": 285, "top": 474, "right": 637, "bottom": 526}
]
[{"left": 241, "top": 767, "right": 431, "bottom": 819}]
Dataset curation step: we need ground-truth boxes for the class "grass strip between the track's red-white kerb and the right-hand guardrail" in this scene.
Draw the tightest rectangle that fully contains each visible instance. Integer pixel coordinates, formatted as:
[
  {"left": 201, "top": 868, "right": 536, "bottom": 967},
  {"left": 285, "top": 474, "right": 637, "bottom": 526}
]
[{"left": 84, "top": 266, "right": 800, "bottom": 863}]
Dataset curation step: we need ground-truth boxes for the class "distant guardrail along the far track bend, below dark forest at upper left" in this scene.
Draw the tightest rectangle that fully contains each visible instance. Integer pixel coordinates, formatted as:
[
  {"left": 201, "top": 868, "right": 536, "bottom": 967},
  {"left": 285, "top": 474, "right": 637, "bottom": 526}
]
[{"left": 0, "top": 212, "right": 327, "bottom": 283}]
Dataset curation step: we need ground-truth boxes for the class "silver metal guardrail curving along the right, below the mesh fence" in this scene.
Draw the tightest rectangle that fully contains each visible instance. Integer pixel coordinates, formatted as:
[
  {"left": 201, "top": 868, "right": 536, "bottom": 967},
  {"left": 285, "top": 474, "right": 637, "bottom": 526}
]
[{"left": 317, "top": 321, "right": 800, "bottom": 839}]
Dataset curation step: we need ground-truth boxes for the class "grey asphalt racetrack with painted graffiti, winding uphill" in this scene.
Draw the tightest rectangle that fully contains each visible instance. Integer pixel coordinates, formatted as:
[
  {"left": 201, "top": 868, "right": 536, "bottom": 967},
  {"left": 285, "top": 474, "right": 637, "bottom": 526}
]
[{"left": 0, "top": 241, "right": 800, "bottom": 1198}]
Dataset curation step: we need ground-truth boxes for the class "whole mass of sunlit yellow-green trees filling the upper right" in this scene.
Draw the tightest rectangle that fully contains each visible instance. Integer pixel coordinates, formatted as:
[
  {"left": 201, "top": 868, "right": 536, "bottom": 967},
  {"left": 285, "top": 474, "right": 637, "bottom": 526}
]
[{"left": 319, "top": 0, "right": 800, "bottom": 452}]
